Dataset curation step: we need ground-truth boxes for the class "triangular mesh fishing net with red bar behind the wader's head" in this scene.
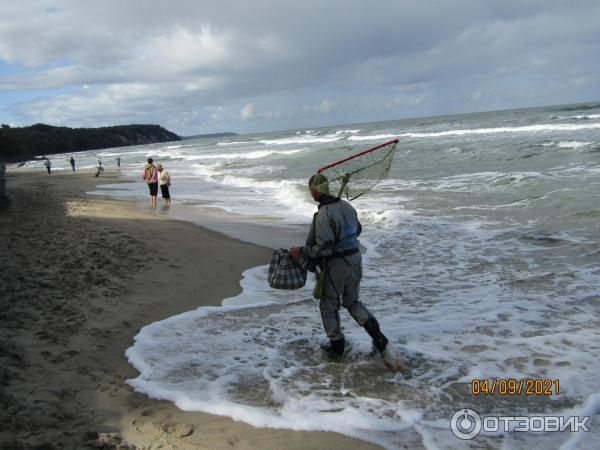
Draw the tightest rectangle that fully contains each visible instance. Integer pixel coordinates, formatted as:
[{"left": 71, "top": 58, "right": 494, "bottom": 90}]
[{"left": 312, "top": 141, "right": 398, "bottom": 200}]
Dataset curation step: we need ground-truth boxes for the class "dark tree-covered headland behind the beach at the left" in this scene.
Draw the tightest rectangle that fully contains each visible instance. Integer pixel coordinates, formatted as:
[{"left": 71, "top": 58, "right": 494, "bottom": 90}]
[{"left": 0, "top": 123, "right": 181, "bottom": 161}]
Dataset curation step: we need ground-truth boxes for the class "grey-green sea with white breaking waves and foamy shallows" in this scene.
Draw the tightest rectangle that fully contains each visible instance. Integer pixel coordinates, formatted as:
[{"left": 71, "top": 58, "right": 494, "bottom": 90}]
[{"left": 12, "top": 102, "right": 600, "bottom": 449}]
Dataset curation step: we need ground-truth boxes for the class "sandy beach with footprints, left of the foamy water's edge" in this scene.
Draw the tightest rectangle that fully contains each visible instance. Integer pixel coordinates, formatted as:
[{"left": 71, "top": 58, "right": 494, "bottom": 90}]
[{"left": 0, "top": 170, "right": 378, "bottom": 449}]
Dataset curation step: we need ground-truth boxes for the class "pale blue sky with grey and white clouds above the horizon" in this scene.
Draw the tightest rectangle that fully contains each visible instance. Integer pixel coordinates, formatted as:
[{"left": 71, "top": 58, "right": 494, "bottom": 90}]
[{"left": 0, "top": 0, "right": 600, "bottom": 136}]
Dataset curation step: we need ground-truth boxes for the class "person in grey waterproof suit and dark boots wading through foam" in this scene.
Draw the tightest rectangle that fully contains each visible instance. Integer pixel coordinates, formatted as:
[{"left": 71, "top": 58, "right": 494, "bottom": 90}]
[{"left": 289, "top": 174, "right": 404, "bottom": 370}]
